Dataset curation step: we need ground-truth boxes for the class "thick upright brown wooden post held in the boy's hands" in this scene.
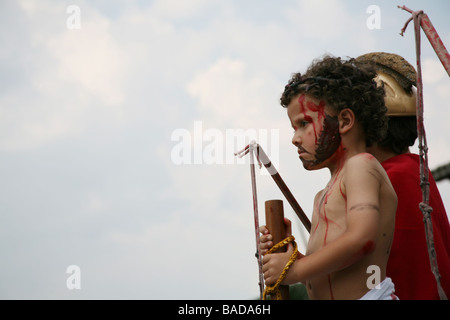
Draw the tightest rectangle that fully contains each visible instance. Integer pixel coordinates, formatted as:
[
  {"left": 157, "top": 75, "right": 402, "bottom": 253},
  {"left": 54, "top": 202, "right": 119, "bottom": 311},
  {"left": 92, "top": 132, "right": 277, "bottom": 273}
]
[{"left": 265, "top": 200, "right": 289, "bottom": 300}]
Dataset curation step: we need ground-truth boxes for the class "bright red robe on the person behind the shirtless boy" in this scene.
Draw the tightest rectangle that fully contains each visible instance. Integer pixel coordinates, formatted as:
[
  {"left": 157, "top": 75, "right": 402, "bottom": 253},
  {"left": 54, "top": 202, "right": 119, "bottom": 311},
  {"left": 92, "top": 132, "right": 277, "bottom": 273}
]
[{"left": 382, "top": 154, "right": 450, "bottom": 300}]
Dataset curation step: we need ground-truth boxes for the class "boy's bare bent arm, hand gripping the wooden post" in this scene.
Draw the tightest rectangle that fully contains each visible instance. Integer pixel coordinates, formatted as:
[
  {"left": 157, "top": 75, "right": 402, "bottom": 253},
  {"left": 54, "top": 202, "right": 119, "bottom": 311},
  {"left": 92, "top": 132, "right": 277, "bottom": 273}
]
[{"left": 263, "top": 156, "right": 381, "bottom": 284}]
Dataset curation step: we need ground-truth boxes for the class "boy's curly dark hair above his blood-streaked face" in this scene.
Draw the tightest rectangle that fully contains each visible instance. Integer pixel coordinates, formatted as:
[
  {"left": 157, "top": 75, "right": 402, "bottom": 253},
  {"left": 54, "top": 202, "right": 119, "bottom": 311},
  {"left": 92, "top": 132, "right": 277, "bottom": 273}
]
[{"left": 280, "top": 56, "right": 388, "bottom": 147}]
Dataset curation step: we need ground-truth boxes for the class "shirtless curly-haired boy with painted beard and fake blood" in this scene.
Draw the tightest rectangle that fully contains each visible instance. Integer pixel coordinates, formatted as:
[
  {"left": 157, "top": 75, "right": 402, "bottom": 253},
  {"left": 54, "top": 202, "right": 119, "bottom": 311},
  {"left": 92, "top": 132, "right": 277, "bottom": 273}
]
[{"left": 263, "top": 56, "right": 397, "bottom": 299}]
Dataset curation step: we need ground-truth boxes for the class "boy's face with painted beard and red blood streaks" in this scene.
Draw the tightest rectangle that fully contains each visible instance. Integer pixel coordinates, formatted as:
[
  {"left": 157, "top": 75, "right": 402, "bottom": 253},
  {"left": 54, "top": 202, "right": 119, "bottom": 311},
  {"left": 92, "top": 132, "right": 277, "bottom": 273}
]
[{"left": 287, "top": 94, "right": 341, "bottom": 170}]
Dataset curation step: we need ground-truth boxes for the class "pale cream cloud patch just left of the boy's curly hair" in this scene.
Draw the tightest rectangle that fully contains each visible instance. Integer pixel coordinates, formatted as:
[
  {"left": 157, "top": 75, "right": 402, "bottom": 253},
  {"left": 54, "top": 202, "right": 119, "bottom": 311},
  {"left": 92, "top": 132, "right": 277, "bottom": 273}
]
[{"left": 187, "top": 58, "right": 287, "bottom": 130}]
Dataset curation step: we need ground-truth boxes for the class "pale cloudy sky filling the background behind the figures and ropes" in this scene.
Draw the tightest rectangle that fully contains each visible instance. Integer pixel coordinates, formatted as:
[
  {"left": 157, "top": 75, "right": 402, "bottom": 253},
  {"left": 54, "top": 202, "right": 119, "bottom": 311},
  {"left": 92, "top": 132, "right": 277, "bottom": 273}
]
[{"left": 0, "top": 0, "right": 450, "bottom": 299}]
